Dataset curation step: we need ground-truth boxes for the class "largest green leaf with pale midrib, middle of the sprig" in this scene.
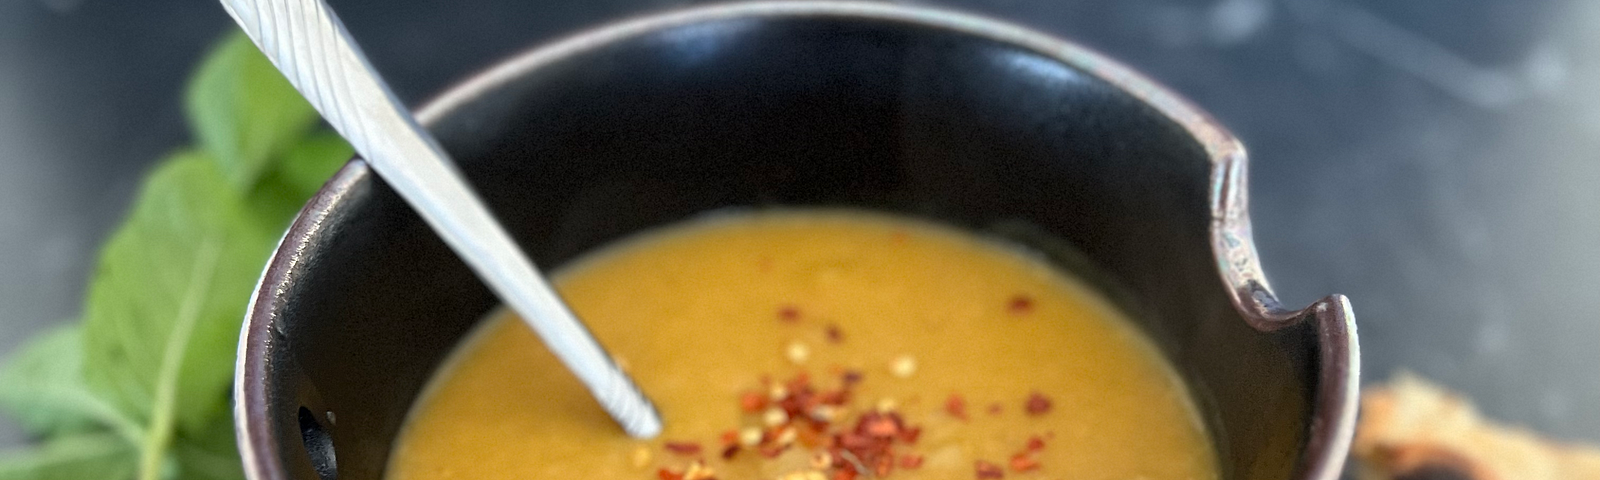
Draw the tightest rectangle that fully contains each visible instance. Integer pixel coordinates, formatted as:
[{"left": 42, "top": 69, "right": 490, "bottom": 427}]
[{"left": 83, "top": 154, "right": 282, "bottom": 454}]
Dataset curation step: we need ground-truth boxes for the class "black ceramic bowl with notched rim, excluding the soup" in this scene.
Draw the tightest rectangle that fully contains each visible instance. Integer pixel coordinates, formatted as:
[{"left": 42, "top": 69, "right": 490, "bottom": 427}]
[{"left": 235, "top": 3, "right": 1358, "bottom": 480}]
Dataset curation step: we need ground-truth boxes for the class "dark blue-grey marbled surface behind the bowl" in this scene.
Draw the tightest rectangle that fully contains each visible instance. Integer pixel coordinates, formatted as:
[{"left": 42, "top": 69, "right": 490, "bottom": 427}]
[{"left": 0, "top": 0, "right": 1600, "bottom": 460}]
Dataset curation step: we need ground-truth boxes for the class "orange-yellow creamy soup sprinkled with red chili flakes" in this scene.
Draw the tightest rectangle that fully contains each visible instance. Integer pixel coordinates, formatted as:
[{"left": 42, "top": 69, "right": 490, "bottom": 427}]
[{"left": 387, "top": 211, "right": 1218, "bottom": 480}]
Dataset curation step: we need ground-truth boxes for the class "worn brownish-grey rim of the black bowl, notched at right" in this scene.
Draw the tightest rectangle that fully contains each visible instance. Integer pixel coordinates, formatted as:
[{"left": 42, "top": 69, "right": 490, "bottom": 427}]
[{"left": 234, "top": 0, "right": 1360, "bottom": 480}]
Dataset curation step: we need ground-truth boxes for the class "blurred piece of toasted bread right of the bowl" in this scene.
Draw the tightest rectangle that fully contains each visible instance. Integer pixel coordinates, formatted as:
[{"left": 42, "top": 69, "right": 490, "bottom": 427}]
[{"left": 1350, "top": 374, "right": 1600, "bottom": 480}]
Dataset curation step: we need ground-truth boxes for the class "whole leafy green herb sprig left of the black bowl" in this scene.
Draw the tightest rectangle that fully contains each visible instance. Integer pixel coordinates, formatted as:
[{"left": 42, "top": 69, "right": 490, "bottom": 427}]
[{"left": 0, "top": 34, "right": 350, "bottom": 480}]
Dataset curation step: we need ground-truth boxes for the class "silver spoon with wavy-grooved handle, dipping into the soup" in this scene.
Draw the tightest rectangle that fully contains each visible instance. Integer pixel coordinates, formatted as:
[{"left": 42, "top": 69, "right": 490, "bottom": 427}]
[{"left": 221, "top": 0, "right": 661, "bottom": 438}]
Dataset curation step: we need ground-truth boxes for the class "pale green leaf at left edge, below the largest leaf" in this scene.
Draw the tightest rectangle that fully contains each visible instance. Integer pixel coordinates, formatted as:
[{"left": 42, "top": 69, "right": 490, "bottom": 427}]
[{"left": 0, "top": 325, "right": 142, "bottom": 440}]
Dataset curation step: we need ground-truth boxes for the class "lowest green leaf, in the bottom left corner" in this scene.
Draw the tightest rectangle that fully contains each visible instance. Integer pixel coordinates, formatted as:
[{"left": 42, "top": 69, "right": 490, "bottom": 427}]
[{"left": 0, "top": 434, "right": 138, "bottom": 480}]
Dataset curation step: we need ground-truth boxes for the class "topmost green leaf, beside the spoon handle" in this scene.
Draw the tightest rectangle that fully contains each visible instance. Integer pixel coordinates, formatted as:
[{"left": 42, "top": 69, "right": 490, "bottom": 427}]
[{"left": 186, "top": 34, "right": 317, "bottom": 189}]
